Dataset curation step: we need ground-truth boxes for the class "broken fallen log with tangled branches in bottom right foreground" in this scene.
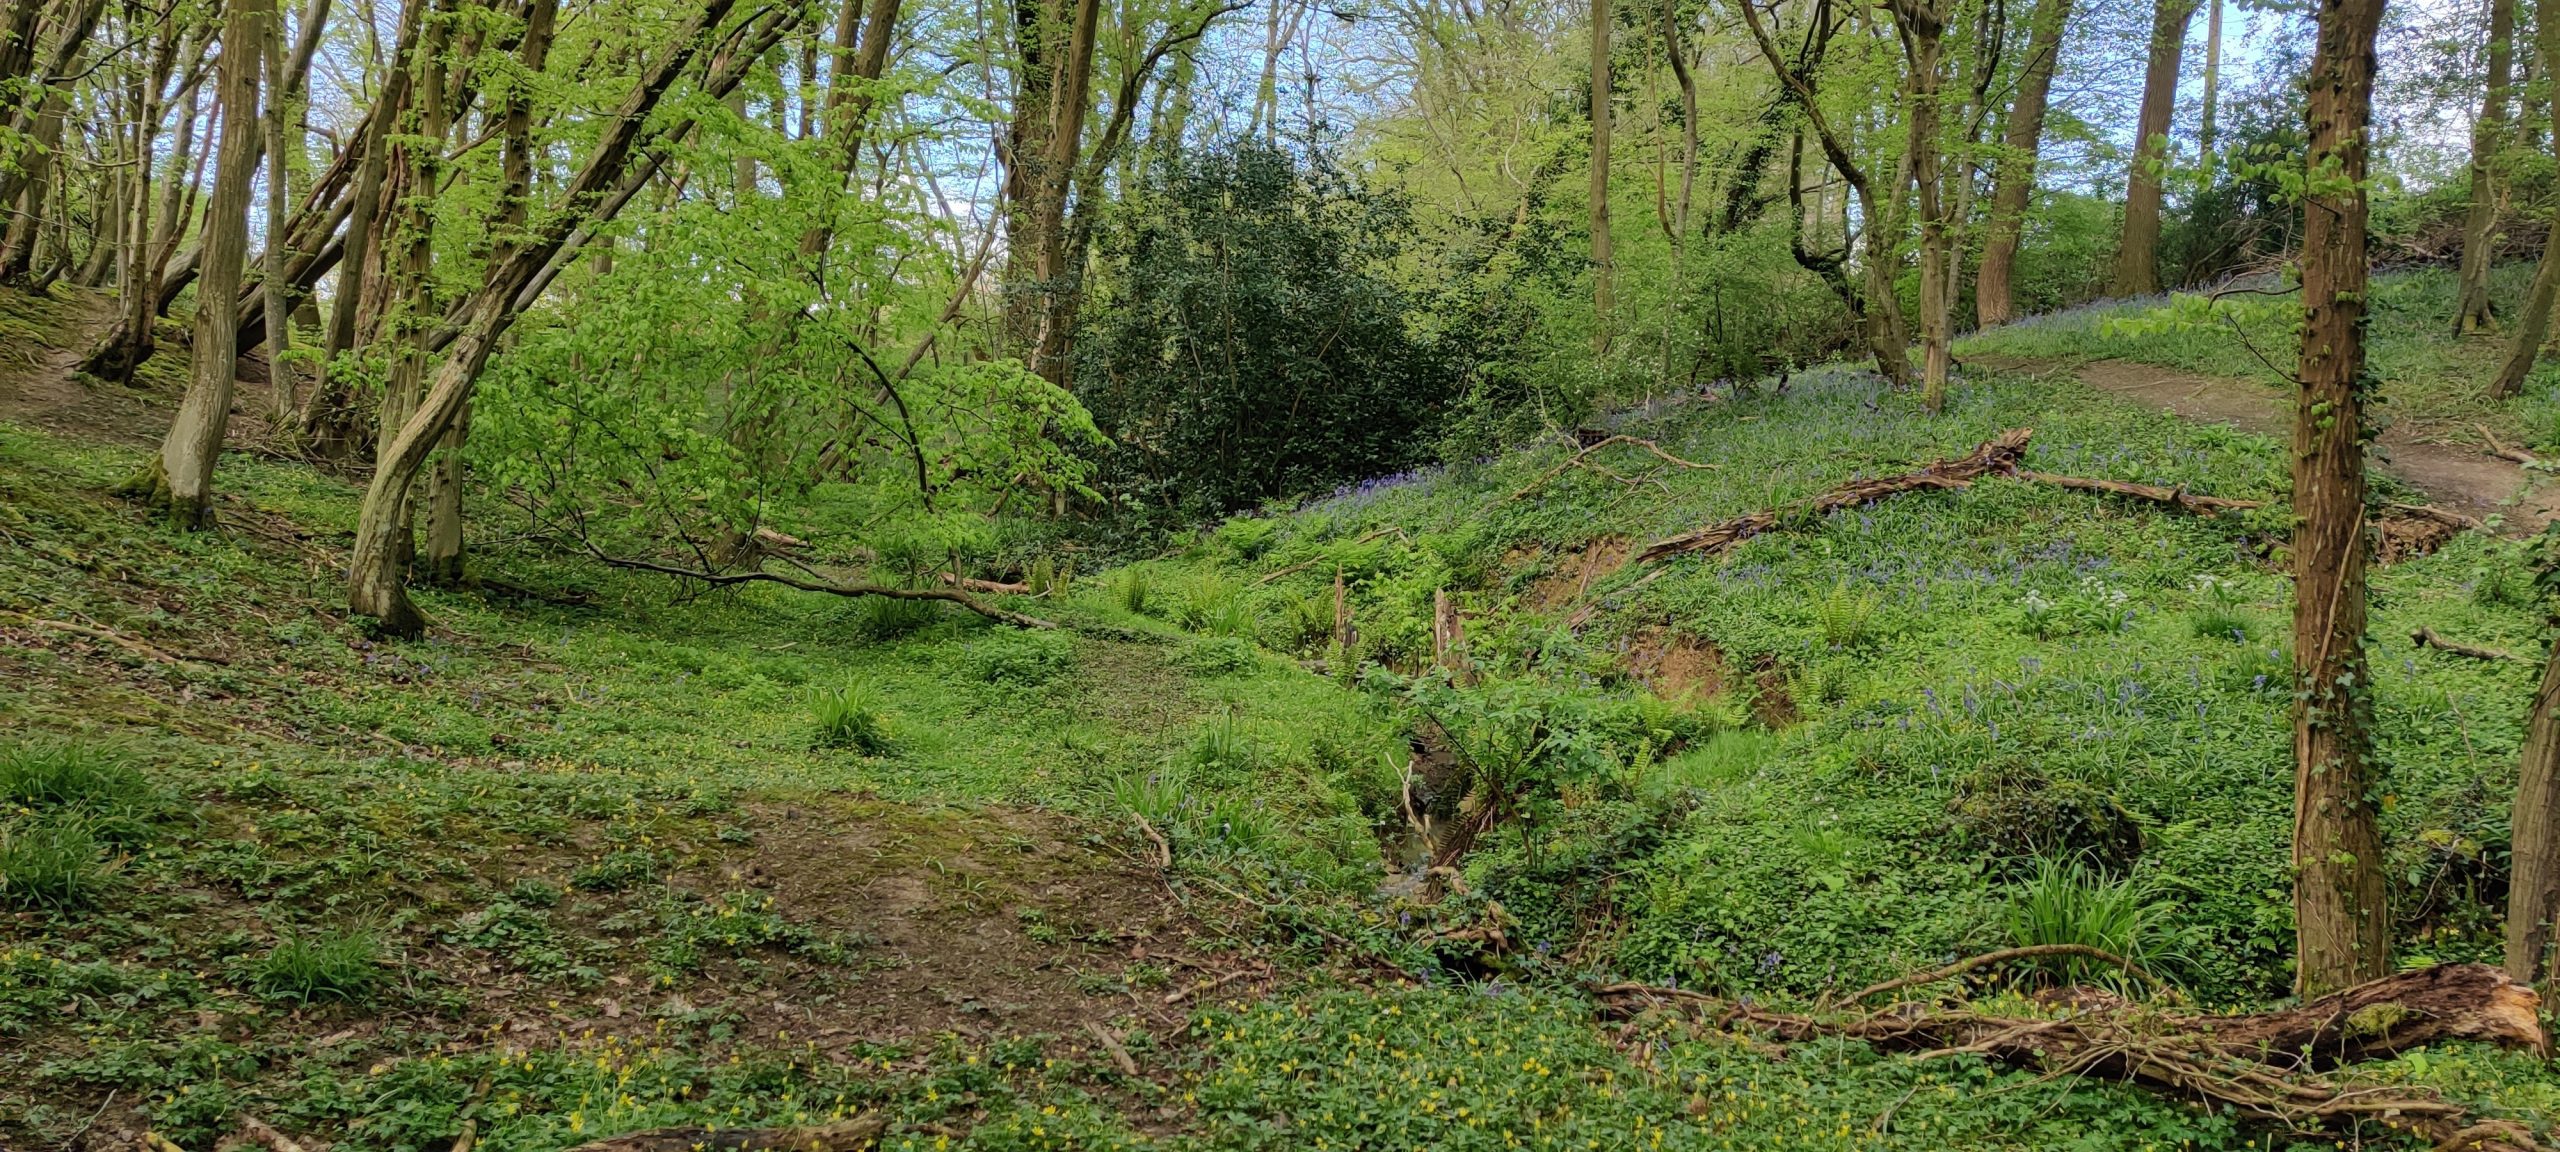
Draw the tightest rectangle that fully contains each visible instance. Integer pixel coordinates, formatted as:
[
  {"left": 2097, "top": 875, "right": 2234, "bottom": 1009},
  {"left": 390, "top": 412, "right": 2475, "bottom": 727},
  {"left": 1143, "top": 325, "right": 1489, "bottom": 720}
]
[{"left": 1595, "top": 965, "right": 2550, "bottom": 1152}]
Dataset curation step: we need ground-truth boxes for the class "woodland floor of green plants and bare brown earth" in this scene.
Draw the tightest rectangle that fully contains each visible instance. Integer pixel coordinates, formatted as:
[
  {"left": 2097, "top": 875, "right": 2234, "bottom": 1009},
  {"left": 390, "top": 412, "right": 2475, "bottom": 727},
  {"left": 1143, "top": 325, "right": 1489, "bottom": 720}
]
[{"left": 0, "top": 272, "right": 2560, "bottom": 1152}]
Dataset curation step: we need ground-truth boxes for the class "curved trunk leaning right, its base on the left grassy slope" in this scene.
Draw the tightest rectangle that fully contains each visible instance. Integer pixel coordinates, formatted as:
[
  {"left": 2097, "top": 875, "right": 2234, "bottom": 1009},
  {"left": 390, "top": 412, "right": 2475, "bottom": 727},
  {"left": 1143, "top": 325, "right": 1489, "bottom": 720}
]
[{"left": 348, "top": 0, "right": 768, "bottom": 635}]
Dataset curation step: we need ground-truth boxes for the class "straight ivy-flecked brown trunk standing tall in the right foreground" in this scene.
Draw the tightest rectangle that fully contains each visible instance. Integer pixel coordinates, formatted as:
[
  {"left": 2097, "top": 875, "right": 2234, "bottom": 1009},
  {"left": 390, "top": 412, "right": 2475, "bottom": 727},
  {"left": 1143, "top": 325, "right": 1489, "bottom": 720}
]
[{"left": 2294, "top": 0, "right": 2391, "bottom": 998}]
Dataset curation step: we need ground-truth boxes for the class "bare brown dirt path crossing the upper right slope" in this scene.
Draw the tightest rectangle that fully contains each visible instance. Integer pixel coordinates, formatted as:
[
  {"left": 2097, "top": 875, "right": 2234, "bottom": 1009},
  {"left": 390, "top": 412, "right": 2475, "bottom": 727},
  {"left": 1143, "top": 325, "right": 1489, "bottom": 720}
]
[{"left": 2074, "top": 361, "right": 2560, "bottom": 535}]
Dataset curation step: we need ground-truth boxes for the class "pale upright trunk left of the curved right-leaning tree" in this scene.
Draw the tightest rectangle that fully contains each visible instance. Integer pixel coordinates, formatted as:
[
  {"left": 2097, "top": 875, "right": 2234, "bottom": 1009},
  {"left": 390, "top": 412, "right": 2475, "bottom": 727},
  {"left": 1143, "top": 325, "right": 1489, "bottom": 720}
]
[{"left": 131, "top": 0, "right": 276, "bottom": 530}]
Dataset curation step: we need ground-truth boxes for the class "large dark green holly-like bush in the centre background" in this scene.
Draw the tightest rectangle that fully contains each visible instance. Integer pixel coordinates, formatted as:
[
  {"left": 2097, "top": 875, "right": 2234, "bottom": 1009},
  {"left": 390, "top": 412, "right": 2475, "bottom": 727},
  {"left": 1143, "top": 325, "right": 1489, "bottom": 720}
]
[{"left": 1075, "top": 143, "right": 1464, "bottom": 517}]
